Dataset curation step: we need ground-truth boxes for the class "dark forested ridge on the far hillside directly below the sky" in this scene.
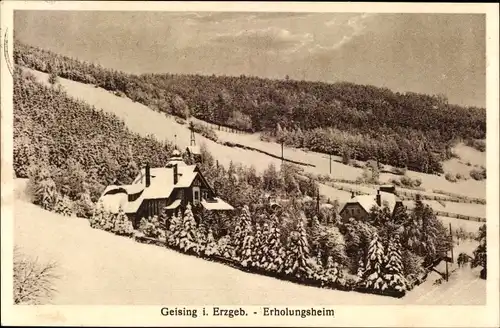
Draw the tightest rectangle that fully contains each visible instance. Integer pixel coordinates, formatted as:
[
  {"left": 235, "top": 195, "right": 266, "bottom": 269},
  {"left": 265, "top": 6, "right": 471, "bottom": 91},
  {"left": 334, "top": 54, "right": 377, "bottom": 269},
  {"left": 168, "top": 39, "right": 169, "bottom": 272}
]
[{"left": 14, "top": 41, "right": 486, "bottom": 173}]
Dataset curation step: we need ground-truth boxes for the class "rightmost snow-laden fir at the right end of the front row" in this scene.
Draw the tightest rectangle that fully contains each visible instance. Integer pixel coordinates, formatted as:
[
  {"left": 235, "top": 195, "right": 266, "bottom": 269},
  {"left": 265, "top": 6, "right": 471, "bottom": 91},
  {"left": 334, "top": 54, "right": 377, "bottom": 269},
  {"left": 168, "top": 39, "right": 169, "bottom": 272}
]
[{"left": 384, "top": 235, "right": 407, "bottom": 292}]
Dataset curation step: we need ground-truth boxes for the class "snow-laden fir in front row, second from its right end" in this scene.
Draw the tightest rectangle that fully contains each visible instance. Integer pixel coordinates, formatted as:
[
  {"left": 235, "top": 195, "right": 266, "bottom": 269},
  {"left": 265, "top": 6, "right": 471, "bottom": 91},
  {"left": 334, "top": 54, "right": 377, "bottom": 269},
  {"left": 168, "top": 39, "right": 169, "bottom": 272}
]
[{"left": 362, "top": 232, "right": 387, "bottom": 290}]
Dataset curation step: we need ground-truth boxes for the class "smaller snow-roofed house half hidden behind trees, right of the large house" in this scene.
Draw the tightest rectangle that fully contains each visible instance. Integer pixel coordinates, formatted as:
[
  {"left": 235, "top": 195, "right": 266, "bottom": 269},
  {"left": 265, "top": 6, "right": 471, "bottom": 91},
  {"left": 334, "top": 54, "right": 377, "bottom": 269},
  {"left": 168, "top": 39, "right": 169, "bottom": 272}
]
[{"left": 339, "top": 186, "right": 403, "bottom": 220}]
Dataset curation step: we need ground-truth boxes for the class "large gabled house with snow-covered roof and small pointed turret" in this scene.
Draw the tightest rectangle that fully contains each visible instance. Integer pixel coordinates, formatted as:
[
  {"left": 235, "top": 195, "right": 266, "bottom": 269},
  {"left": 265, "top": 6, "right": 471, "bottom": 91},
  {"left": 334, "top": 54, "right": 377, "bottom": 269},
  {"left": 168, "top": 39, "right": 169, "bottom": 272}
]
[{"left": 100, "top": 149, "right": 234, "bottom": 228}]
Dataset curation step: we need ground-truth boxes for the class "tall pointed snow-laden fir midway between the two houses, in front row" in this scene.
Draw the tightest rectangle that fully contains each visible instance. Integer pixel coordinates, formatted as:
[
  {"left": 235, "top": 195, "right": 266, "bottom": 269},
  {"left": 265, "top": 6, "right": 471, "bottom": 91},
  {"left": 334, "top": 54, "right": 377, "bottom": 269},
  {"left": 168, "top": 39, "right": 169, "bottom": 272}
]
[{"left": 284, "top": 220, "right": 311, "bottom": 279}]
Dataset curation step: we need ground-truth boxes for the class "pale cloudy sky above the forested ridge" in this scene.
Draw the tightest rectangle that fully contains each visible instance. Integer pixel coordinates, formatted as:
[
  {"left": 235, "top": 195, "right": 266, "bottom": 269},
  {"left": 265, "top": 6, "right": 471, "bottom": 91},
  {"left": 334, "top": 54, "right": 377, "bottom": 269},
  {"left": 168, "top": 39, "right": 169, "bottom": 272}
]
[{"left": 14, "top": 11, "right": 486, "bottom": 107}]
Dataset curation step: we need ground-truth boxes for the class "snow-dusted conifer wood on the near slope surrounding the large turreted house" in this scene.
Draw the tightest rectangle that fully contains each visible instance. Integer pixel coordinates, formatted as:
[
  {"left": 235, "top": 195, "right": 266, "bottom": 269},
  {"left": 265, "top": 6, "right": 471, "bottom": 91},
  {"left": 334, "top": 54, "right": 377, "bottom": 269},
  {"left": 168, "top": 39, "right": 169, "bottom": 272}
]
[{"left": 14, "top": 63, "right": 484, "bottom": 296}]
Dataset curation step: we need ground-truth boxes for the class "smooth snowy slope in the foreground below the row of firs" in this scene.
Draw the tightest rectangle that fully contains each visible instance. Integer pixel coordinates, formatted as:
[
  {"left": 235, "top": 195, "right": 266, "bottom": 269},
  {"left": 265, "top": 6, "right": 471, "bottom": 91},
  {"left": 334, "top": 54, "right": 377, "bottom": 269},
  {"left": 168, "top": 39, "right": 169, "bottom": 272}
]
[{"left": 14, "top": 180, "right": 486, "bottom": 306}]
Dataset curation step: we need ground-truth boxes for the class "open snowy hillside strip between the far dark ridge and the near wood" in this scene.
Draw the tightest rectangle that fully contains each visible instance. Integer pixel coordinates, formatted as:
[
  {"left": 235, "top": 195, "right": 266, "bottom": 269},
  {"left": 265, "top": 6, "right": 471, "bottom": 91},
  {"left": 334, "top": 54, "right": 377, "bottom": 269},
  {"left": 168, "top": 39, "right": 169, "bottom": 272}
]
[{"left": 23, "top": 68, "right": 486, "bottom": 198}]
